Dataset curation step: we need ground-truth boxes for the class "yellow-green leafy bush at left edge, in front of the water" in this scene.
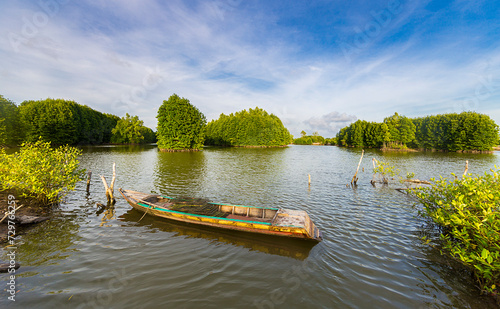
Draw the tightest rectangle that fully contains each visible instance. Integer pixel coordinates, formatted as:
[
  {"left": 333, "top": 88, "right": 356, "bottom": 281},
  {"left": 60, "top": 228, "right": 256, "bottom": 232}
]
[{"left": 0, "top": 141, "right": 85, "bottom": 205}]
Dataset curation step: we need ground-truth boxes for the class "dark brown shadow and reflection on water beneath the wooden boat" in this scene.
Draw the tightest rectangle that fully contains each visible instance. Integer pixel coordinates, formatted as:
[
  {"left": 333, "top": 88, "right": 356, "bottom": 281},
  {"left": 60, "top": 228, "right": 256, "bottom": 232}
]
[{"left": 118, "top": 209, "right": 317, "bottom": 261}]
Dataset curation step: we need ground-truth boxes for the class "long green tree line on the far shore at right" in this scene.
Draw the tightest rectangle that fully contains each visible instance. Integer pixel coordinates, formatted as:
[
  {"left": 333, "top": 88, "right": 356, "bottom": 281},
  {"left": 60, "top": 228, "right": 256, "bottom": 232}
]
[{"left": 336, "top": 112, "right": 499, "bottom": 151}]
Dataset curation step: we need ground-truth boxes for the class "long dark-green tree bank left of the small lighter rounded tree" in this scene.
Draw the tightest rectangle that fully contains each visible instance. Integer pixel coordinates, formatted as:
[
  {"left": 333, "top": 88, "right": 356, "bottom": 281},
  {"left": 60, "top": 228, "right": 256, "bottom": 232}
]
[{"left": 19, "top": 99, "right": 120, "bottom": 145}]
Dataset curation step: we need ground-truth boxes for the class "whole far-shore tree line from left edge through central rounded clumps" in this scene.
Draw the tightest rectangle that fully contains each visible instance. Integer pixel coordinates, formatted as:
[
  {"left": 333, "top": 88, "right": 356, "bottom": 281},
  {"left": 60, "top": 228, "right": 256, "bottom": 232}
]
[{"left": 0, "top": 94, "right": 292, "bottom": 151}]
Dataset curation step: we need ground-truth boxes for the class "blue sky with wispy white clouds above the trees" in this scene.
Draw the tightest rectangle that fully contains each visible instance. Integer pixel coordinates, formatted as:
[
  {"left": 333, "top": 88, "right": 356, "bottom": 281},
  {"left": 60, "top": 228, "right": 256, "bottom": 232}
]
[{"left": 0, "top": 0, "right": 500, "bottom": 137}]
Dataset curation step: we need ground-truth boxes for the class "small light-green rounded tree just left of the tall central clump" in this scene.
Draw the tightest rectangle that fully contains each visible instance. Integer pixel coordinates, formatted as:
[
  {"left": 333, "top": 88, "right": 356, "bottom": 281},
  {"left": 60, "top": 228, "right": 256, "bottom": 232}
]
[{"left": 111, "top": 113, "right": 156, "bottom": 144}]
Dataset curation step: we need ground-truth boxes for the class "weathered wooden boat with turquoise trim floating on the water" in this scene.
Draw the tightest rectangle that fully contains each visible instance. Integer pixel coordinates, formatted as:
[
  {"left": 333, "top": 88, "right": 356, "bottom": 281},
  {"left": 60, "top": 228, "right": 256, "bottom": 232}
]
[{"left": 118, "top": 188, "right": 322, "bottom": 242}]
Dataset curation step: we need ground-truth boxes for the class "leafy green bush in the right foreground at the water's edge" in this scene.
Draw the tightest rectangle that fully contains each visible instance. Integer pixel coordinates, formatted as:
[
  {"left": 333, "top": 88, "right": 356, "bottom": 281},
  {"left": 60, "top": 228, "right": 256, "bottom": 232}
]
[{"left": 410, "top": 170, "right": 500, "bottom": 293}]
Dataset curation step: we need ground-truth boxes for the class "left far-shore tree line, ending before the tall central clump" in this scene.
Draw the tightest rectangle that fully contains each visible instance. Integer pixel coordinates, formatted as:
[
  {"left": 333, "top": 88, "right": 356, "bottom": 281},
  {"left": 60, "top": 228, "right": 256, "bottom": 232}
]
[{"left": 0, "top": 95, "right": 156, "bottom": 146}]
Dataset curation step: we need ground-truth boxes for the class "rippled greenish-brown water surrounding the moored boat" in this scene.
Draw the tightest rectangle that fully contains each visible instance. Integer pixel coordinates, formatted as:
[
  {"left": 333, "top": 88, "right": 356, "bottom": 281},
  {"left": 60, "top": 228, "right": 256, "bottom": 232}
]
[{"left": 0, "top": 146, "right": 500, "bottom": 308}]
